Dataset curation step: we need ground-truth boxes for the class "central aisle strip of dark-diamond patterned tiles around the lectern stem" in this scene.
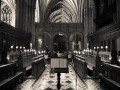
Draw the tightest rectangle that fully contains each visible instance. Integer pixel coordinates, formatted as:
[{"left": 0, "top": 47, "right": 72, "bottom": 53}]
[{"left": 31, "top": 66, "right": 86, "bottom": 90}]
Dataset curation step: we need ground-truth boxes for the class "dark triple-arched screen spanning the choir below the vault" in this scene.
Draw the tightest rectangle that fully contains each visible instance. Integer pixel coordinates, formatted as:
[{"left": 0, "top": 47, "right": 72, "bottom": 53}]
[{"left": 36, "top": 23, "right": 84, "bottom": 55}]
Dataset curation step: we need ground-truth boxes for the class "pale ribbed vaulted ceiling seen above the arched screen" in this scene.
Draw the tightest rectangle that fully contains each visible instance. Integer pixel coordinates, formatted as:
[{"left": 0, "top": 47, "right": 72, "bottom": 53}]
[{"left": 36, "top": 0, "right": 84, "bottom": 23}]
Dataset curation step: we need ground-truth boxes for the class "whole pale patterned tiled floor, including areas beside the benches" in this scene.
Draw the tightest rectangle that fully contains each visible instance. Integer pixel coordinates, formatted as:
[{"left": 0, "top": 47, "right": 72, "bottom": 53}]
[{"left": 15, "top": 66, "right": 107, "bottom": 90}]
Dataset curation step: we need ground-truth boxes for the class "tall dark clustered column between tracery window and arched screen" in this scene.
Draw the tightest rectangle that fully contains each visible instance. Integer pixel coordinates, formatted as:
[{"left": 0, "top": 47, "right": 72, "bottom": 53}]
[{"left": 16, "top": 0, "right": 35, "bottom": 46}]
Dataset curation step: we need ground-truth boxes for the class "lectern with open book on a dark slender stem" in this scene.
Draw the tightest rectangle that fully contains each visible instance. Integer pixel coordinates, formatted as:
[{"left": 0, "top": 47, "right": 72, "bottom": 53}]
[{"left": 50, "top": 58, "right": 69, "bottom": 90}]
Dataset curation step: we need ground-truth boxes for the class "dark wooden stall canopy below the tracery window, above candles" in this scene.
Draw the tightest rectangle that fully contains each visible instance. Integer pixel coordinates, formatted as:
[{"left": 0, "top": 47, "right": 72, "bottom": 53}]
[{"left": 0, "top": 21, "right": 32, "bottom": 52}]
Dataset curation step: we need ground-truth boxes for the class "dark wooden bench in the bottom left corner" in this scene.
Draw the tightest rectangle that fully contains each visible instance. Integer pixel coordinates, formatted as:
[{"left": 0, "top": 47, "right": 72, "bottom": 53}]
[{"left": 0, "top": 63, "right": 23, "bottom": 90}]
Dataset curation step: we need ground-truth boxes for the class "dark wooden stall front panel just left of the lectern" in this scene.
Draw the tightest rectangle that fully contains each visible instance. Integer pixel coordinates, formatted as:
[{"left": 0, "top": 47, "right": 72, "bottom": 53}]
[{"left": 32, "top": 57, "right": 45, "bottom": 79}]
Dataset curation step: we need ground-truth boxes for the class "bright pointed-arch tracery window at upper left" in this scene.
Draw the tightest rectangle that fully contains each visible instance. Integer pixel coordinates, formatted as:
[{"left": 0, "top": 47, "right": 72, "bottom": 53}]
[{"left": 1, "top": 5, "right": 12, "bottom": 24}]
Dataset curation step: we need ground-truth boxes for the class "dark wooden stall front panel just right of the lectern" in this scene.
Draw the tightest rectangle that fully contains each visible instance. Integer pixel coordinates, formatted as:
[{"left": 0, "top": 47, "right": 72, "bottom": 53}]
[{"left": 73, "top": 56, "right": 87, "bottom": 78}]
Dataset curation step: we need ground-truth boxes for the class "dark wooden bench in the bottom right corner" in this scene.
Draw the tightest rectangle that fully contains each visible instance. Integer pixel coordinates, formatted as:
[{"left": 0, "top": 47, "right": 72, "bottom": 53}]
[{"left": 99, "top": 63, "right": 120, "bottom": 90}]
